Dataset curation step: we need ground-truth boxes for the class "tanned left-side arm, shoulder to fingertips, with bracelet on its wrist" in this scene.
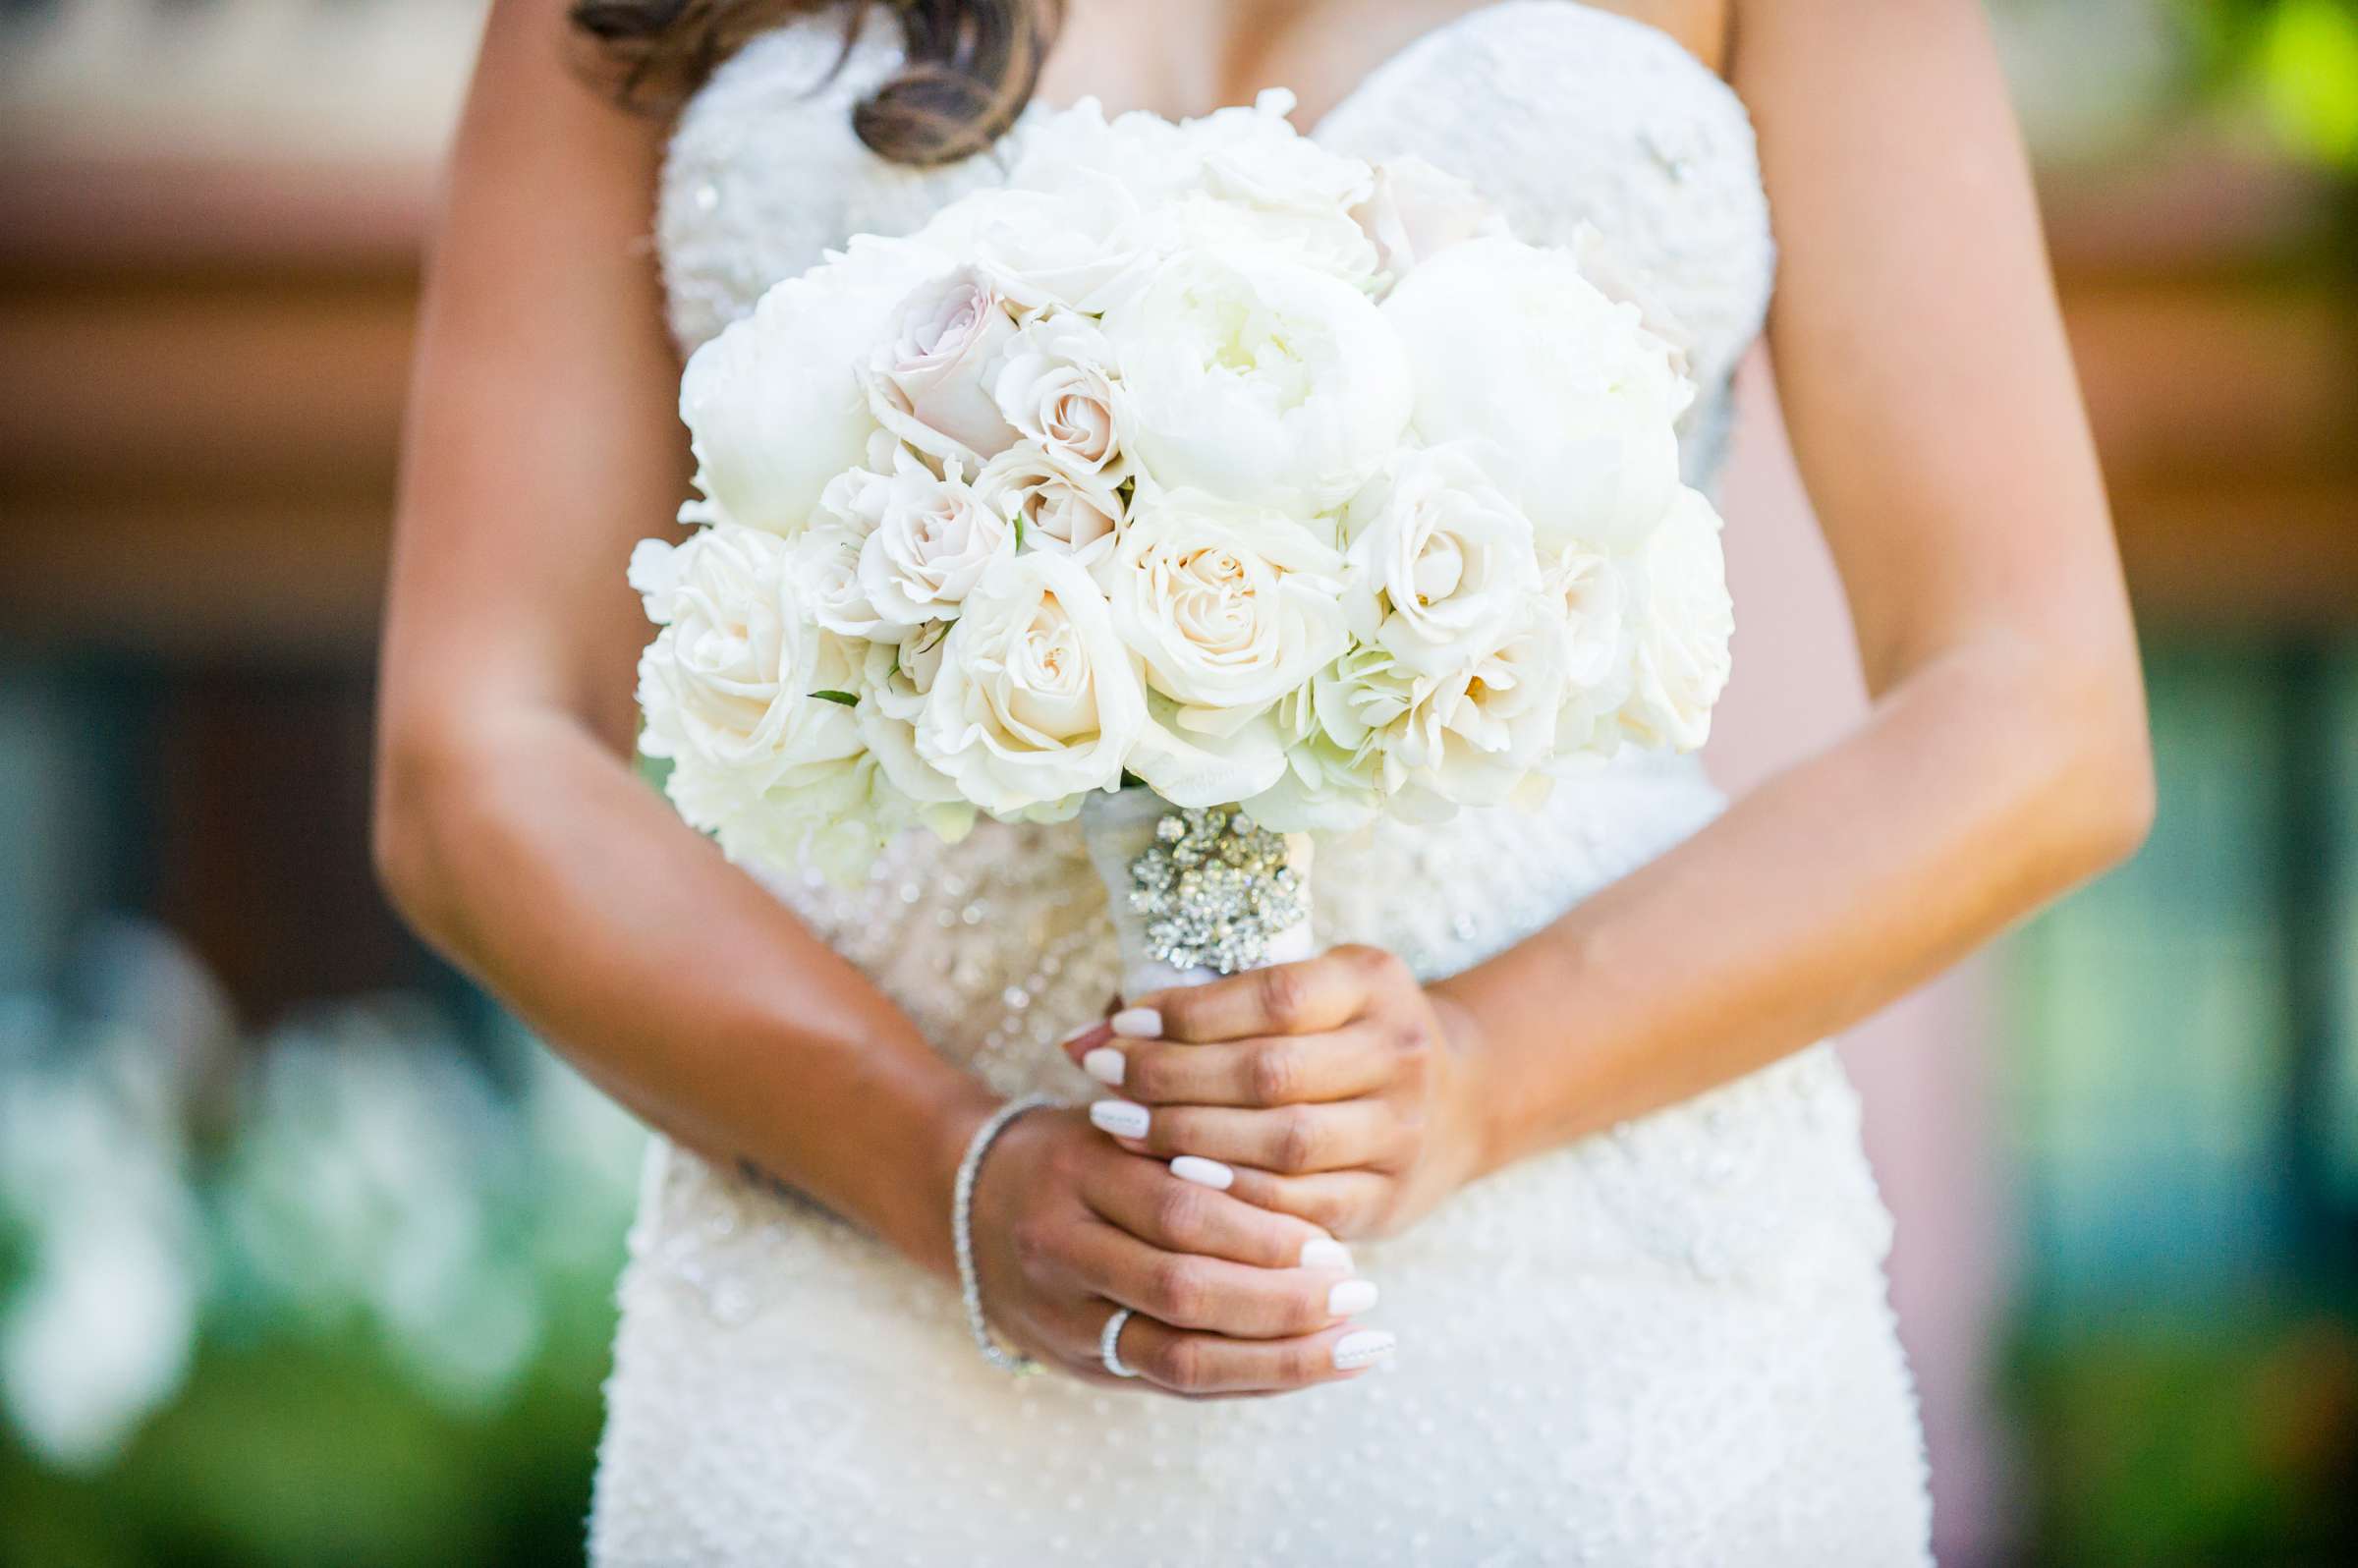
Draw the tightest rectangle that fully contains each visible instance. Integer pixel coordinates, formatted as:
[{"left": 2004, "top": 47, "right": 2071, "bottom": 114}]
[{"left": 377, "top": 0, "right": 1376, "bottom": 1393}]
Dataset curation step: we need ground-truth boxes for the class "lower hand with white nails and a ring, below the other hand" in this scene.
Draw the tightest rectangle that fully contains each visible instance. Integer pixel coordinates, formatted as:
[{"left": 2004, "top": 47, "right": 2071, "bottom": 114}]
[{"left": 974, "top": 1110, "right": 1389, "bottom": 1396}]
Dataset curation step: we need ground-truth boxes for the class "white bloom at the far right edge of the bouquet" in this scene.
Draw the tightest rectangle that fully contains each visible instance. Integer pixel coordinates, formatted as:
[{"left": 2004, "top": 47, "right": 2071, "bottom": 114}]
[{"left": 1622, "top": 490, "right": 1735, "bottom": 753}]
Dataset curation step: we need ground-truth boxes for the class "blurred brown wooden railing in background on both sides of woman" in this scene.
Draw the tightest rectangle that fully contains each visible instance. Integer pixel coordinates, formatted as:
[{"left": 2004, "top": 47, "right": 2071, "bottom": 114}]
[{"left": 0, "top": 139, "right": 2358, "bottom": 662}]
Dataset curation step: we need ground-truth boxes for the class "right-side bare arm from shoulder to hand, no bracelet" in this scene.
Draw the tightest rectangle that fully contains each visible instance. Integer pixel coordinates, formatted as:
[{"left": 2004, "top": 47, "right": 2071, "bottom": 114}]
[{"left": 1080, "top": 0, "right": 2153, "bottom": 1231}]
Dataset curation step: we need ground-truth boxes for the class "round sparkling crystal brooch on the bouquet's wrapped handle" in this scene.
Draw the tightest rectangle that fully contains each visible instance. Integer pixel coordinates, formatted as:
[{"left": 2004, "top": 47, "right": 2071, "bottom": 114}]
[{"left": 1130, "top": 807, "right": 1309, "bottom": 974}]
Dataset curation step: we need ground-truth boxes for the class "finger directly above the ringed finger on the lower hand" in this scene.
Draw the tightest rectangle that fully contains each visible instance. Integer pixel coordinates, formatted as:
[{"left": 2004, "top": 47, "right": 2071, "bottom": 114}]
[{"left": 1066, "top": 1224, "right": 1375, "bottom": 1339}]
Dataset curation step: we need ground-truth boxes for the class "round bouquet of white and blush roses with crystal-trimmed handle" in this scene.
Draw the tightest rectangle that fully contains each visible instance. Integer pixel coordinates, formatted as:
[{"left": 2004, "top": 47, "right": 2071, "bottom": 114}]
[{"left": 632, "top": 94, "right": 1731, "bottom": 974}]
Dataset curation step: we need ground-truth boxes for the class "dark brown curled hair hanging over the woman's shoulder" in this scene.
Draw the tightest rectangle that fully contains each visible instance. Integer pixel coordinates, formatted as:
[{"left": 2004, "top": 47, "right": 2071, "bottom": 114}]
[{"left": 571, "top": 0, "right": 1063, "bottom": 165}]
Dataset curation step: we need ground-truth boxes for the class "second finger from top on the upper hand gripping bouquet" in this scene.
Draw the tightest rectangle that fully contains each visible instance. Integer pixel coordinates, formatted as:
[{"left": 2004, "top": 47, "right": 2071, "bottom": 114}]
[{"left": 1098, "top": 1026, "right": 1393, "bottom": 1106}]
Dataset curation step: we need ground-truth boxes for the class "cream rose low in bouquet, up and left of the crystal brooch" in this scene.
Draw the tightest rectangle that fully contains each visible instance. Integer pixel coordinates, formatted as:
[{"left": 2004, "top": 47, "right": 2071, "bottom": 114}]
[{"left": 918, "top": 549, "right": 1146, "bottom": 815}]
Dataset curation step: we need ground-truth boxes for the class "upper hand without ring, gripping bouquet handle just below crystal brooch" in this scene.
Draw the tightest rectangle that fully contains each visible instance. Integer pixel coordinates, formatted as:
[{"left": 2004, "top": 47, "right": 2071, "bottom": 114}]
[{"left": 1066, "top": 948, "right": 1484, "bottom": 1238}]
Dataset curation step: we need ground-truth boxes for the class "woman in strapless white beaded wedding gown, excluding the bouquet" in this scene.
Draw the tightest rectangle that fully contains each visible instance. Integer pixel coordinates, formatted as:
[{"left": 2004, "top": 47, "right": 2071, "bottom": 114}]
[{"left": 377, "top": 0, "right": 2151, "bottom": 1566}]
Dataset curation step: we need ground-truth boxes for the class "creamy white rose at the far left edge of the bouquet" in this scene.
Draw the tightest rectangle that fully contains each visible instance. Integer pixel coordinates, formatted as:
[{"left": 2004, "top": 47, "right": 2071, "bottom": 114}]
[{"left": 632, "top": 524, "right": 861, "bottom": 827}]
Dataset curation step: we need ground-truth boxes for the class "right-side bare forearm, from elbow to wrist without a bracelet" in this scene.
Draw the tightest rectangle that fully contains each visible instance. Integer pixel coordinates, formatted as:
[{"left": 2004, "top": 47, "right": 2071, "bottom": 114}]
[{"left": 1436, "top": 639, "right": 2153, "bottom": 1169}]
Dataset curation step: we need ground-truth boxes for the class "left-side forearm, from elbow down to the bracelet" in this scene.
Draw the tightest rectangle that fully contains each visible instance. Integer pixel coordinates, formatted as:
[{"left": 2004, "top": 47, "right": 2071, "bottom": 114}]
[{"left": 377, "top": 712, "right": 990, "bottom": 1271}]
